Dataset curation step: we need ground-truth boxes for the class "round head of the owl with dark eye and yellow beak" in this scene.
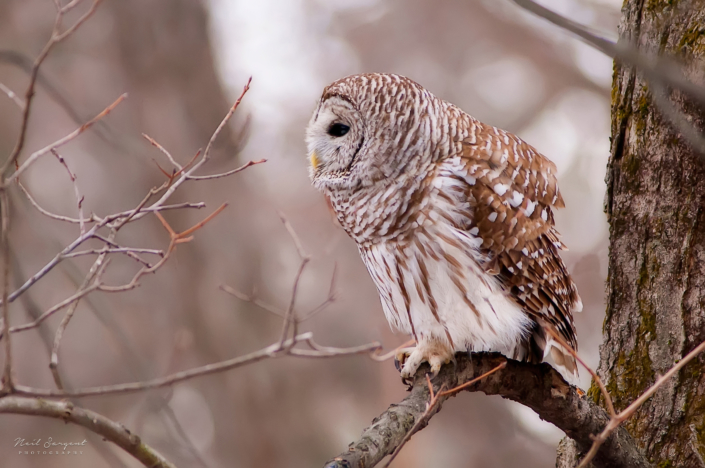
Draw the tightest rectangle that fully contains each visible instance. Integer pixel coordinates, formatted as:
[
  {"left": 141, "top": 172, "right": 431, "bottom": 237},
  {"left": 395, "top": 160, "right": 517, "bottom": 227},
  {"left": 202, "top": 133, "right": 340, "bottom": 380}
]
[{"left": 306, "top": 73, "right": 442, "bottom": 191}]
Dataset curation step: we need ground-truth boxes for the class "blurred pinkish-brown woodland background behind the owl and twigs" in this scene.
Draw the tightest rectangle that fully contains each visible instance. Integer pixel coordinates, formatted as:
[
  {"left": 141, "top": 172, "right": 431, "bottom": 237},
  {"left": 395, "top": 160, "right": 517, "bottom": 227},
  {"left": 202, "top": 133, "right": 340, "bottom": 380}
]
[{"left": 0, "top": 0, "right": 621, "bottom": 468}]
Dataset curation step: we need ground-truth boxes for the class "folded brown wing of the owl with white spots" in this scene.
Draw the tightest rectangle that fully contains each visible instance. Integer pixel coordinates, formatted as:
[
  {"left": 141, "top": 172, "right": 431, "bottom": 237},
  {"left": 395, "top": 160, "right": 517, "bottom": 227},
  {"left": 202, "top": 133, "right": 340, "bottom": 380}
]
[{"left": 445, "top": 122, "right": 582, "bottom": 372}]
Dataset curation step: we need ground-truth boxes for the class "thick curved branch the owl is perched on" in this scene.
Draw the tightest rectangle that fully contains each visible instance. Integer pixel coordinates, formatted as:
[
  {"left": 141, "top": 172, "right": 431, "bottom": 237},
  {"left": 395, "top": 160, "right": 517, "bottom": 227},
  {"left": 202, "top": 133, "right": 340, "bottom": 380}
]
[{"left": 325, "top": 353, "right": 651, "bottom": 468}]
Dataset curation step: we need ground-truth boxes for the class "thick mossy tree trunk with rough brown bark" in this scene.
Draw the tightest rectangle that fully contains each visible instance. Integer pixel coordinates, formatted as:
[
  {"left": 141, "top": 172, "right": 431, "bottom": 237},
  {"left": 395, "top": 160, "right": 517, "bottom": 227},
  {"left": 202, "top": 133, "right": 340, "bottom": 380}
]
[{"left": 559, "top": 0, "right": 705, "bottom": 467}]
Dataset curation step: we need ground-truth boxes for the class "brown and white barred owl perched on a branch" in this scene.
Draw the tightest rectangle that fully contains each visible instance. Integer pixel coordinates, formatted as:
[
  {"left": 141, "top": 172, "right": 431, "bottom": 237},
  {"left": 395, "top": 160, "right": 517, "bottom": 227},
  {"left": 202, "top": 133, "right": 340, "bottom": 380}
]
[{"left": 306, "top": 73, "right": 582, "bottom": 381}]
